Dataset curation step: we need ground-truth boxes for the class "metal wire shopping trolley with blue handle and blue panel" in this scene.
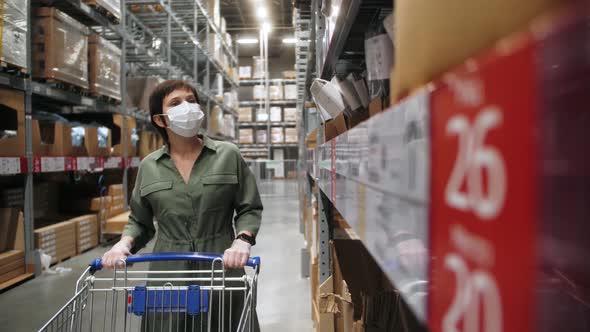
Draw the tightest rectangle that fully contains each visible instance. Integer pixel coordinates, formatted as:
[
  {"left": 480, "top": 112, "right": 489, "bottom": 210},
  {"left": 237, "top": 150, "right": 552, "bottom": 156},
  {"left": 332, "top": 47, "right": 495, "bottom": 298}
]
[{"left": 39, "top": 253, "right": 260, "bottom": 332}]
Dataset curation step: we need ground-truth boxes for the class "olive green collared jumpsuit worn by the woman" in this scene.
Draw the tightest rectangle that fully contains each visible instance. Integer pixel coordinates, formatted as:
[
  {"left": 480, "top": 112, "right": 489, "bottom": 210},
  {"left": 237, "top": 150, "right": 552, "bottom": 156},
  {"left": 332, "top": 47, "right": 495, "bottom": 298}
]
[{"left": 123, "top": 136, "right": 262, "bottom": 331}]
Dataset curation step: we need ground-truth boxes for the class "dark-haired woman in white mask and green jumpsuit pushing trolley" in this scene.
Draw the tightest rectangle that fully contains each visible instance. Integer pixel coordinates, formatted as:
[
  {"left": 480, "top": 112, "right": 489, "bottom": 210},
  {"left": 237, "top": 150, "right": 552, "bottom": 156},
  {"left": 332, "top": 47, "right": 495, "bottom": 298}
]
[{"left": 102, "top": 80, "right": 262, "bottom": 331}]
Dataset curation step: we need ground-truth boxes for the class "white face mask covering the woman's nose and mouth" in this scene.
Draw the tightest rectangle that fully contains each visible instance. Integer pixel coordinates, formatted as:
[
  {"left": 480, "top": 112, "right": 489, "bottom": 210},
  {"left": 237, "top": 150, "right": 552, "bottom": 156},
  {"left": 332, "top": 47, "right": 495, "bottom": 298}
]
[{"left": 166, "top": 101, "right": 205, "bottom": 137}]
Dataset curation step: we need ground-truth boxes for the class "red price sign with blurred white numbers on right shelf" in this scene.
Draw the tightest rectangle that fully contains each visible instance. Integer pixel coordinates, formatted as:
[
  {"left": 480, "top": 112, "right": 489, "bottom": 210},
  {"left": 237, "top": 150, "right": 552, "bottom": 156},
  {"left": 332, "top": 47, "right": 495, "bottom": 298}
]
[{"left": 429, "top": 40, "right": 539, "bottom": 332}]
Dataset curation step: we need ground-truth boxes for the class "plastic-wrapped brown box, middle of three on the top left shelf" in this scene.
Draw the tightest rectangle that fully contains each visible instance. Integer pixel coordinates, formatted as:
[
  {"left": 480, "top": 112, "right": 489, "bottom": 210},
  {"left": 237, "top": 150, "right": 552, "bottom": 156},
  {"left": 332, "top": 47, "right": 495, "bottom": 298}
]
[{"left": 32, "top": 7, "right": 89, "bottom": 89}]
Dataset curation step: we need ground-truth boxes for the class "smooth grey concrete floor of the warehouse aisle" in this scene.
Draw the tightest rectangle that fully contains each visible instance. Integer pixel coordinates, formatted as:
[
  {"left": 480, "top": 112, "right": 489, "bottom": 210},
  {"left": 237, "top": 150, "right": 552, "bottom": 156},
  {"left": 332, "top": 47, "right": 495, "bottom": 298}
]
[{"left": 0, "top": 180, "right": 313, "bottom": 332}]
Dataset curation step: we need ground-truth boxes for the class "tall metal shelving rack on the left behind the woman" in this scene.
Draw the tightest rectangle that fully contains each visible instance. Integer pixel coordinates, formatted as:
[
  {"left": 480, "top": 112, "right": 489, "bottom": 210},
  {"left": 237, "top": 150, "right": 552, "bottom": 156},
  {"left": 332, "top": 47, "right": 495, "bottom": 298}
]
[{"left": 0, "top": 0, "right": 239, "bottom": 282}]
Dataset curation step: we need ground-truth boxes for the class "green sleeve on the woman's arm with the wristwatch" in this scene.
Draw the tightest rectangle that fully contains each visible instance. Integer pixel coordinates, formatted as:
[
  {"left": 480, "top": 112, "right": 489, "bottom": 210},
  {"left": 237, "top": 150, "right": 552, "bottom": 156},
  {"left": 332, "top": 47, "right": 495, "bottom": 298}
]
[{"left": 234, "top": 155, "right": 262, "bottom": 236}]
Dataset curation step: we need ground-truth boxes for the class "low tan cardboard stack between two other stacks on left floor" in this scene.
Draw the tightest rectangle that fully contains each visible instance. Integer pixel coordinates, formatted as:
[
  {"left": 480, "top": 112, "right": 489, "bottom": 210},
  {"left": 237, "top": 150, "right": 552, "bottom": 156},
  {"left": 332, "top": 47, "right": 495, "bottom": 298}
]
[{"left": 35, "top": 221, "right": 77, "bottom": 263}]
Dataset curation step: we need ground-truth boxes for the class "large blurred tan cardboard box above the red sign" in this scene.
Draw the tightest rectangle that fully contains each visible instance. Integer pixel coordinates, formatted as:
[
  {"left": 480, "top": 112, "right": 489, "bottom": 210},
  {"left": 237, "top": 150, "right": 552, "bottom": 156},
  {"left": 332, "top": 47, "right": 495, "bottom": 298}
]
[{"left": 391, "top": 0, "right": 561, "bottom": 103}]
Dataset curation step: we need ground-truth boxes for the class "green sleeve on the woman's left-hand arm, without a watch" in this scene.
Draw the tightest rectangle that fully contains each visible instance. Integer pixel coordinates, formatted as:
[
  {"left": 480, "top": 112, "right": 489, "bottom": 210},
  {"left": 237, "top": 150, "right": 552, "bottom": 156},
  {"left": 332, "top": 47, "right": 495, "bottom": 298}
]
[{"left": 122, "top": 165, "right": 156, "bottom": 253}]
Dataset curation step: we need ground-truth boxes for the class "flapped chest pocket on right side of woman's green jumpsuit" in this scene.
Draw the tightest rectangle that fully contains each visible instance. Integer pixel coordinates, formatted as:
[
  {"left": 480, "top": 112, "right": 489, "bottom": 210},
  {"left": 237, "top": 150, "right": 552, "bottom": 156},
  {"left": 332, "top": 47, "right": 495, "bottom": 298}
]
[{"left": 201, "top": 174, "right": 238, "bottom": 211}]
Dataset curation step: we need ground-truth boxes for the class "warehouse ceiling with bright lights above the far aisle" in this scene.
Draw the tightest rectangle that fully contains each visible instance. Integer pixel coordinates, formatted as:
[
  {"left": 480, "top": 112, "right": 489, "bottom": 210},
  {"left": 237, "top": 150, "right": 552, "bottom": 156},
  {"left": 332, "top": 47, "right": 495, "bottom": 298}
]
[{"left": 220, "top": 0, "right": 293, "bottom": 57}]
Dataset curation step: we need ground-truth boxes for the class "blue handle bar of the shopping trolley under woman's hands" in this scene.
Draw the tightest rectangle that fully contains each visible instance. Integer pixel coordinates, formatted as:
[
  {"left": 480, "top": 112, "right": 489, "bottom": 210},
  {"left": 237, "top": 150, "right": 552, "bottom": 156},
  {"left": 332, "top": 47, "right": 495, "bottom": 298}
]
[{"left": 89, "top": 252, "right": 260, "bottom": 273}]
